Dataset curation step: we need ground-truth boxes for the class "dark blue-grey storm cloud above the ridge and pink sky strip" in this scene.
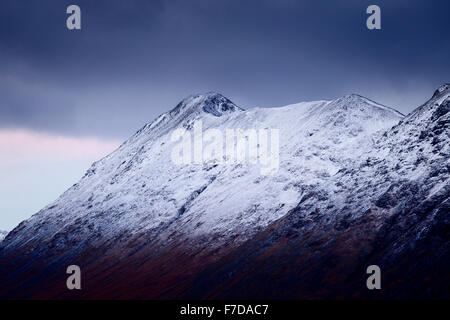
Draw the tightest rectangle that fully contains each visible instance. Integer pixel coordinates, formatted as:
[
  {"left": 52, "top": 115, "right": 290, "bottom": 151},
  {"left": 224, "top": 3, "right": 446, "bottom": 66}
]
[{"left": 0, "top": 0, "right": 450, "bottom": 138}]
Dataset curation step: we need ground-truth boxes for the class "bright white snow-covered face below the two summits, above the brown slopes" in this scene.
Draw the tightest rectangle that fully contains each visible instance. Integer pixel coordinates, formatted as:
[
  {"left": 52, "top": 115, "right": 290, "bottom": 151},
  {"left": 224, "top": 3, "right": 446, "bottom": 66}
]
[{"left": 1, "top": 93, "right": 402, "bottom": 255}]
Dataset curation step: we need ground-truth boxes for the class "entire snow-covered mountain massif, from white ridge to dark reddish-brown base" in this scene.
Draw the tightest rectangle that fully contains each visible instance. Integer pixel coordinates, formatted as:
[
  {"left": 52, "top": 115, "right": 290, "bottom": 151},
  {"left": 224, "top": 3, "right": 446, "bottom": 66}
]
[{"left": 0, "top": 85, "right": 450, "bottom": 298}]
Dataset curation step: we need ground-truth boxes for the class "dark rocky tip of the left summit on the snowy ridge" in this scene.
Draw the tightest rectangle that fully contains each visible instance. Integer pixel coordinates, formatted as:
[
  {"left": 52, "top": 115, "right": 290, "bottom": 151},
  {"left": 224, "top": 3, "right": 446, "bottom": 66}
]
[{"left": 170, "top": 92, "right": 243, "bottom": 117}]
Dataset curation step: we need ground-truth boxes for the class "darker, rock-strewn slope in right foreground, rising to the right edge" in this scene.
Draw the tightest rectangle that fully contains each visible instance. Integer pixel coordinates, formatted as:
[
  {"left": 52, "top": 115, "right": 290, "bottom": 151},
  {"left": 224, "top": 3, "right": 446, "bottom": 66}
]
[{"left": 190, "top": 84, "right": 450, "bottom": 299}]
